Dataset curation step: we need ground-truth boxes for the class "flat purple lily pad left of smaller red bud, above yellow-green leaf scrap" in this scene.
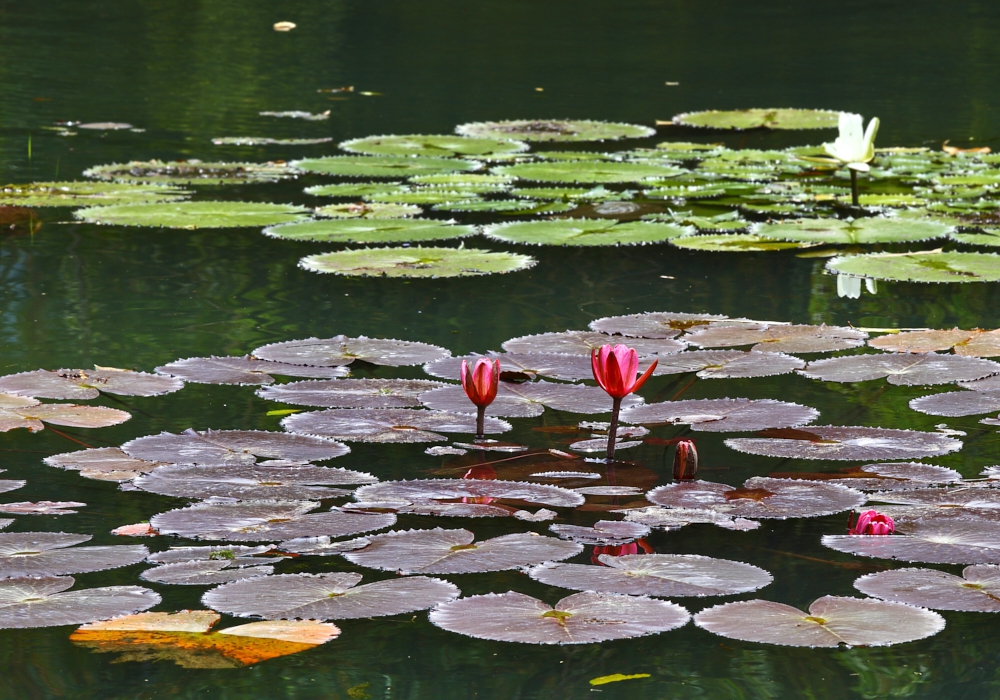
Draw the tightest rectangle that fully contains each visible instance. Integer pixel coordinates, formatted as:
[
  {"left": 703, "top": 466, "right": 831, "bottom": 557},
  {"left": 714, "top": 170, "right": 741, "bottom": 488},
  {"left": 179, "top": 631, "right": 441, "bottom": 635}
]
[{"left": 257, "top": 379, "right": 446, "bottom": 408}]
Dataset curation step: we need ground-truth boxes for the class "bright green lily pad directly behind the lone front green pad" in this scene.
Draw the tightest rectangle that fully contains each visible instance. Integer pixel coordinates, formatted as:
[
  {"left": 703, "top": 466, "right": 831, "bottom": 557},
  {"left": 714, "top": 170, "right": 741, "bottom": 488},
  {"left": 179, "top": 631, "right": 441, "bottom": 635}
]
[{"left": 264, "top": 219, "right": 476, "bottom": 243}]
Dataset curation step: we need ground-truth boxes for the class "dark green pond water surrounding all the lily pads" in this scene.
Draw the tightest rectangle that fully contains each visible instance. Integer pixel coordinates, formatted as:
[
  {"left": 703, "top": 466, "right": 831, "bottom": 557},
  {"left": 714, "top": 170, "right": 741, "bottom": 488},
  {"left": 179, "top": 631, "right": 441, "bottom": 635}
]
[{"left": 0, "top": 0, "right": 1000, "bottom": 699}]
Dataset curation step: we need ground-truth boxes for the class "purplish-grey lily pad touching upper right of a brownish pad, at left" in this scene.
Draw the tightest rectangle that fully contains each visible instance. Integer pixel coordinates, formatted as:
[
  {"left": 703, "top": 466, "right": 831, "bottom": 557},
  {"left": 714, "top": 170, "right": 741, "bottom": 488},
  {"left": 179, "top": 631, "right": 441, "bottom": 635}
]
[{"left": 122, "top": 429, "right": 351, "bottom": 465}]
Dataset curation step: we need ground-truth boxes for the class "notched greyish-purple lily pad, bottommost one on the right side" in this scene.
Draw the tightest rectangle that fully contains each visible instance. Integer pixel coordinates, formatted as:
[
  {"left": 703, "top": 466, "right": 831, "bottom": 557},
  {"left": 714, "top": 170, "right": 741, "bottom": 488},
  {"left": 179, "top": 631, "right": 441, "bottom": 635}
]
[{"left": 694, "top": 595, "right": 944, "bottom": 648}]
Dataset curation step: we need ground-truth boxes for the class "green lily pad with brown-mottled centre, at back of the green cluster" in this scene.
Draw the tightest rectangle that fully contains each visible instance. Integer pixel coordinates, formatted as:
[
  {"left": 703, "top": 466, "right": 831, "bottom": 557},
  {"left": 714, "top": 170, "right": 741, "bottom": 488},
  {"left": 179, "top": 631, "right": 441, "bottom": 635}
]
[{"left": 455, "top": 119, "right": 656, "bottom": 141}]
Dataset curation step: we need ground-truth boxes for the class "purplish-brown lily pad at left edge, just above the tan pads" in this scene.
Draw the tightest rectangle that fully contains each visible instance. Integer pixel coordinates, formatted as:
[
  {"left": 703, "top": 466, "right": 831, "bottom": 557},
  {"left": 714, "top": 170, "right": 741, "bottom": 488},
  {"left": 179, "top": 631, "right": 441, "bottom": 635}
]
[{"left": 0, "top": 369, "right": 184, "bottom": 400}]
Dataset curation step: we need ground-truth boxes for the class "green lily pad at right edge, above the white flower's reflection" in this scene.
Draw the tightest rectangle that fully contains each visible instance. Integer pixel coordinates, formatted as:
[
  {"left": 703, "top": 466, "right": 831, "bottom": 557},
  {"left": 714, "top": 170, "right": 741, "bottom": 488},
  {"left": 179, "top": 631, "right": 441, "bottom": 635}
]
[{"left": 826, "top": 252, "right": 1000, "bottom": 282}]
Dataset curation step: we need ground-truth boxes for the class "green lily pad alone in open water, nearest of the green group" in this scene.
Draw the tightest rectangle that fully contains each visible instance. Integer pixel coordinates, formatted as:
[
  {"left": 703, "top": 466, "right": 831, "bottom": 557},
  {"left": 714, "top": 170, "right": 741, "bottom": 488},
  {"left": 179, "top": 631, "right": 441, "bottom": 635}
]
[{"left": 299, "top": 246, "right": 537, "bottom": 277}]
